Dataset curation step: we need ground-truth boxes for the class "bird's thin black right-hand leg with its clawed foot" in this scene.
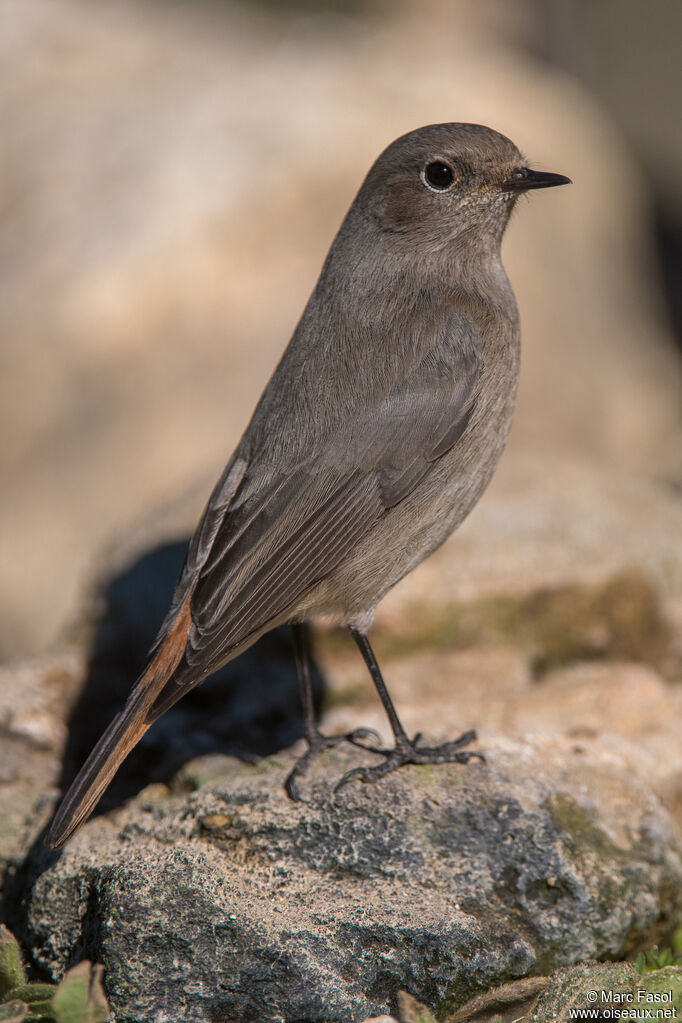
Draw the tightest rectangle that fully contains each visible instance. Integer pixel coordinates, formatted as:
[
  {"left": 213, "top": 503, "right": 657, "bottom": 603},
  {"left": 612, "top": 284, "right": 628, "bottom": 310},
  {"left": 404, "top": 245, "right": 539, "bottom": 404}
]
[{"left": 334, "top": 626, "right": 486, "bottom": 792}]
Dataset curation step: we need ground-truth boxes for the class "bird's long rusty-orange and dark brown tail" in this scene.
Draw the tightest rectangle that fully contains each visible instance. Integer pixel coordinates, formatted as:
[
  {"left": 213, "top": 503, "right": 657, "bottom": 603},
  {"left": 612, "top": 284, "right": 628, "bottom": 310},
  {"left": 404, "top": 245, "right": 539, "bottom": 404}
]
[{"left": 45, "top": 601, "right": 191, "bottom": 849}]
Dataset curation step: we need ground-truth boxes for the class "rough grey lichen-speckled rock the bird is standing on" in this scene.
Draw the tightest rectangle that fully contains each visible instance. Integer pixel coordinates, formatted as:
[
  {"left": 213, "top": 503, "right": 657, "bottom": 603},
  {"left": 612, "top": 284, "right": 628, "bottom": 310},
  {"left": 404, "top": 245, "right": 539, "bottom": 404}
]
[{"left": 24, "top": 735, "right": 682, "bottom": 1023}]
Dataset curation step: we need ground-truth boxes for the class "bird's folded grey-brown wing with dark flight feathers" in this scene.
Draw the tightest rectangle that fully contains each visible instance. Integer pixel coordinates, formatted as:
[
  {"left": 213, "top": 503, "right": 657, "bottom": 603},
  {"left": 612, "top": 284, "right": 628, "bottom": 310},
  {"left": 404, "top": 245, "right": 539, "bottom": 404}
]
[{"left": 153, "top": 319, "right": 481, "bottom": 714}]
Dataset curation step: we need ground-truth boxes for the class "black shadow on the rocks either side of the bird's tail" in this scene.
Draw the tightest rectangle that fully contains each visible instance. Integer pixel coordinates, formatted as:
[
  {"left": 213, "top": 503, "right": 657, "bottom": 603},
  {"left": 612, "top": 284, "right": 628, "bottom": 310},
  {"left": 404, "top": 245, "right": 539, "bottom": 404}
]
[{"left": 60, "top": 540, "right": 322, "bottom": 813}]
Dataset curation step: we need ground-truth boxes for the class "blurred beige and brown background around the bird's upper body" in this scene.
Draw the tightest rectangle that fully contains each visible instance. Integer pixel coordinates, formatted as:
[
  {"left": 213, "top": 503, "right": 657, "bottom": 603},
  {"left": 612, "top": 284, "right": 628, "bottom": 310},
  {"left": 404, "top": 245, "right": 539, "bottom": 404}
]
[{"left": 0, "top": 0, "right": 682, "bottom": 659}]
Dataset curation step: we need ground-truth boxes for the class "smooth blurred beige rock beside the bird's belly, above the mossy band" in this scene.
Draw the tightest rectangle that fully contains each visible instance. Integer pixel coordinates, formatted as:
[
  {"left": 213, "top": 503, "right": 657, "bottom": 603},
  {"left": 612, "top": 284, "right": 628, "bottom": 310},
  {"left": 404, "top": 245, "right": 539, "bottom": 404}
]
[{"left": 376, "top": 446, "right": 682, "bottom": 625}]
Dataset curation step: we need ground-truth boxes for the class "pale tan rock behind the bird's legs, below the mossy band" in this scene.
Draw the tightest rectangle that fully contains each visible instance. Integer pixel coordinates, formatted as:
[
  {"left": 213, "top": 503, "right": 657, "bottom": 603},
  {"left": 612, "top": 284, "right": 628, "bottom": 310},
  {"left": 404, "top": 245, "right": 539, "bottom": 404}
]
[{"left": 322, "top": 647, "right": 682, "bottom": 855}]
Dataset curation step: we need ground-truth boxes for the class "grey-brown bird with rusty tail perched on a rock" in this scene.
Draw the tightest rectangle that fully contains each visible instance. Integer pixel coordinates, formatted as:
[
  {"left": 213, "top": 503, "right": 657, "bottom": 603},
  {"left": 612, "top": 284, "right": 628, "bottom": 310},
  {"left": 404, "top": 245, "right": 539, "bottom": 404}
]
[{"left": 45, "top": 123, "right": 571, "bottom": 848}]
